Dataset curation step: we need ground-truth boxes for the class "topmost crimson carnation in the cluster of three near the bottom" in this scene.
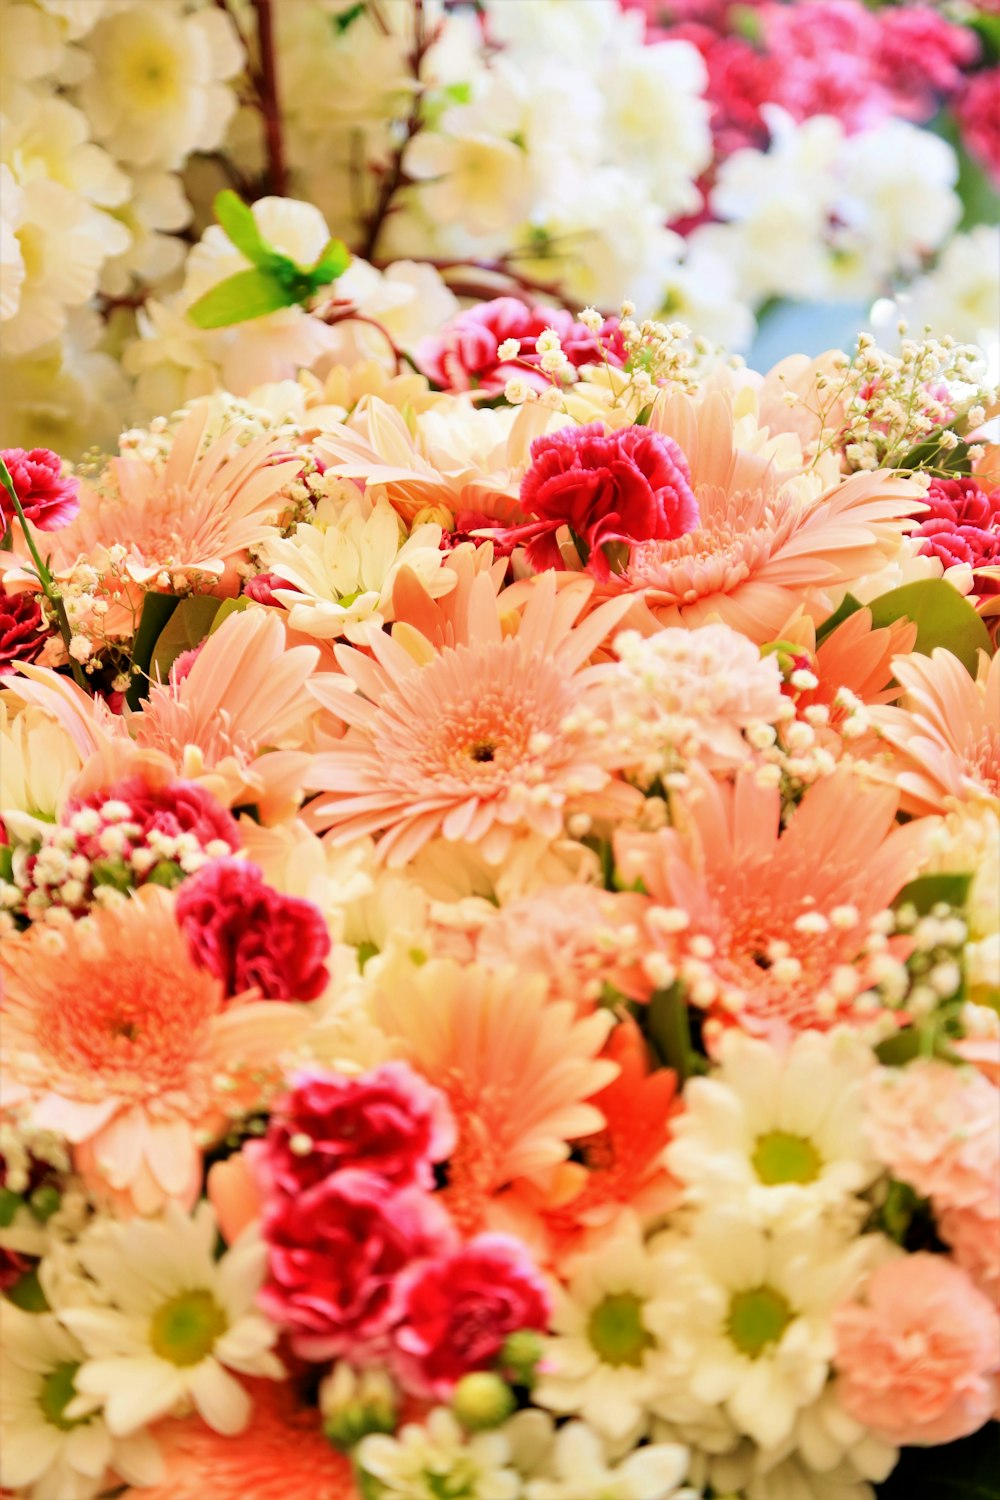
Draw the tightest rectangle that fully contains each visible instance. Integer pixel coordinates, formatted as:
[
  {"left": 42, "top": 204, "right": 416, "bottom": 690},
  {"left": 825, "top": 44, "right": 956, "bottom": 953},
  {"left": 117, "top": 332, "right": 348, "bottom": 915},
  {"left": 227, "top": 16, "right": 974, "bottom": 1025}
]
[{"left": 250, "top": 1062, "right": 454, "bottom": 1197}]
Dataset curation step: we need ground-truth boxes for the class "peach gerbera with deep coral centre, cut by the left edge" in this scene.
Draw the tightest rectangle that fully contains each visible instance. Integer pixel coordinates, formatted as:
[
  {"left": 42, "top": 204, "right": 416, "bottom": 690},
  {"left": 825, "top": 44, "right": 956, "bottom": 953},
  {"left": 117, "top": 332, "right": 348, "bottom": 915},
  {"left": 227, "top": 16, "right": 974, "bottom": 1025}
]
[{"left": 0, "top": 885, "right": 307, "bottom": 1214}]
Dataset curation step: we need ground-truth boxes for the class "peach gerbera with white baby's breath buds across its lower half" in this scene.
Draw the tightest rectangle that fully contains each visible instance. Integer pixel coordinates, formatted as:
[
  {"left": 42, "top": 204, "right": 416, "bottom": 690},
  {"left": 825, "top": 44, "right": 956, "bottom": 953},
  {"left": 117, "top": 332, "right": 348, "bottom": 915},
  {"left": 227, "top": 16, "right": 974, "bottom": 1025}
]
[{"left": 616, "top": 767, "right": 930, "bottom": 1041}]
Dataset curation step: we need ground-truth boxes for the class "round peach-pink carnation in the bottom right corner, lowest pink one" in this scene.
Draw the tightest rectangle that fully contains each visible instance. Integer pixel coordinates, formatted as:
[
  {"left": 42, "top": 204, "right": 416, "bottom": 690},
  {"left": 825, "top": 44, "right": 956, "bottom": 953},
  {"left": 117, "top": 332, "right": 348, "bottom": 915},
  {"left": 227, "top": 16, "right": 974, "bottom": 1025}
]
[{"left": 834, "top": 1254, "right": 1000, "bottom": 1445}]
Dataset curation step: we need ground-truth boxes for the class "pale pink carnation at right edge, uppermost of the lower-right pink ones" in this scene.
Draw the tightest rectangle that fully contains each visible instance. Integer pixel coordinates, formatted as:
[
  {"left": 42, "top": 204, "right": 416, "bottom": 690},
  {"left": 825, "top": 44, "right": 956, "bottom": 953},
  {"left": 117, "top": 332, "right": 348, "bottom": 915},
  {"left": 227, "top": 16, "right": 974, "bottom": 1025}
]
[{"left": 867, "top": 1059, "right": 1000, "bottom": 1212}]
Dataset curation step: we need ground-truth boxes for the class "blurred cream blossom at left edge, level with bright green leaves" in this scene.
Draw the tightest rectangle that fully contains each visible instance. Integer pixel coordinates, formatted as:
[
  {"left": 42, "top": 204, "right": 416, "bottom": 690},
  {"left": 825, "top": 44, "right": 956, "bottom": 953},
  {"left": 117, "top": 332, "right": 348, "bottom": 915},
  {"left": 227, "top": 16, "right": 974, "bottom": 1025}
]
[{"left": 3, "top": 177, "right": 129, "bottom": 357}]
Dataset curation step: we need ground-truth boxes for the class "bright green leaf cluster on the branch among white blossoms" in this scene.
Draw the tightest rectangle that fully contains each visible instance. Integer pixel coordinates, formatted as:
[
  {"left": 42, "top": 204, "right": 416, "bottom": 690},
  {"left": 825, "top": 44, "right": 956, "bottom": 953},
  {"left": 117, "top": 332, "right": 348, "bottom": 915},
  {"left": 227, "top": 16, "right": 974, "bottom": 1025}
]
[{"left": 187, "top": 188, "right": 351, "bottom": 329}]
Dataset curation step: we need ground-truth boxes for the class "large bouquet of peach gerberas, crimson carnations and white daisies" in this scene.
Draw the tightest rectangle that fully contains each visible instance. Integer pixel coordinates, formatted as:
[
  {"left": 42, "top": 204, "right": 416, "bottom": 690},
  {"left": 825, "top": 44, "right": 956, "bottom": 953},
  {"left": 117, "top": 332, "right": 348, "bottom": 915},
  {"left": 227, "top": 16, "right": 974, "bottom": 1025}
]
[{"left": 0, "top": 205, "right": 1000, "bottom": 1500}]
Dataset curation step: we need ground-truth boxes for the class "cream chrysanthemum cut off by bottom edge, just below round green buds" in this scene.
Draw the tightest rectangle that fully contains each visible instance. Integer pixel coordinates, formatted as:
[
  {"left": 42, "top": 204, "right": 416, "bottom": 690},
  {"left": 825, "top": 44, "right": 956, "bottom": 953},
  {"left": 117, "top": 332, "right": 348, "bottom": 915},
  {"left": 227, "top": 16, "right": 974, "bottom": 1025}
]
[{"left": 354, "top": 1407, "right": 522, "bottom": 1500}]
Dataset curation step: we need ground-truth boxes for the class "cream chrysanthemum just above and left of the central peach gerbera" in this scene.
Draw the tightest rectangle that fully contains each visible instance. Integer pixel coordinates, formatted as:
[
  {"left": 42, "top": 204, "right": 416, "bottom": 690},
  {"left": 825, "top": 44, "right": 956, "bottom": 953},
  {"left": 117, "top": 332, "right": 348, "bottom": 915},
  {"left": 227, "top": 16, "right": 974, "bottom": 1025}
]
[{"left": 259, "top": 485, "right": 454, "bottom": 645}]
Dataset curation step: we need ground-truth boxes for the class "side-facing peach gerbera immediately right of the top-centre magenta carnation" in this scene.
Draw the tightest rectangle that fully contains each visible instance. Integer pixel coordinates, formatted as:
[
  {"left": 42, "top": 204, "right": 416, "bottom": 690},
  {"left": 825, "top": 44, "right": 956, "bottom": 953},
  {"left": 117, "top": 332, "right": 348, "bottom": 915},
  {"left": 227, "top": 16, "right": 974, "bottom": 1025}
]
[{"left": 612, "top": 393, "right": 921, "bottom": 645}]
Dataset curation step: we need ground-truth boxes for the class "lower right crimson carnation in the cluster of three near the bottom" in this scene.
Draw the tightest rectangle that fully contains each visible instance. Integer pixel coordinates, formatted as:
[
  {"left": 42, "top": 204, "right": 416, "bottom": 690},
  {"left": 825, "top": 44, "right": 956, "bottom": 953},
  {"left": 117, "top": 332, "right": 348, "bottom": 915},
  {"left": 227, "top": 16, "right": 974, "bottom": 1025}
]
[{"left": 393, "top": 1235, "right": 552, "bottom": 1398}]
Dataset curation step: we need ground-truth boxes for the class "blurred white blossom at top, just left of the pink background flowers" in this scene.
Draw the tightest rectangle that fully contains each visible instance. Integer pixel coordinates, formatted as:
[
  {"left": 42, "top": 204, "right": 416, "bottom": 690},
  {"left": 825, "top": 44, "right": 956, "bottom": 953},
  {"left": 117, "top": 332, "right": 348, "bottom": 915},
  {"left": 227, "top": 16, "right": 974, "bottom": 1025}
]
[{"left": 606, "top": 42, "right": 712, "bottom": 219}]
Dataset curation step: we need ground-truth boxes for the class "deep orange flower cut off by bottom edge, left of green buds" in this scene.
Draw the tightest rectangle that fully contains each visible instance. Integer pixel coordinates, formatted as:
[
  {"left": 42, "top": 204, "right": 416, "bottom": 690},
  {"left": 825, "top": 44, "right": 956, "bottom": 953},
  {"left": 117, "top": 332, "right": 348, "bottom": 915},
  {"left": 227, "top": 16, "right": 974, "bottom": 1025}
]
[{"left": 123, "top": 1380, "right": 358, "bottom": 1500}]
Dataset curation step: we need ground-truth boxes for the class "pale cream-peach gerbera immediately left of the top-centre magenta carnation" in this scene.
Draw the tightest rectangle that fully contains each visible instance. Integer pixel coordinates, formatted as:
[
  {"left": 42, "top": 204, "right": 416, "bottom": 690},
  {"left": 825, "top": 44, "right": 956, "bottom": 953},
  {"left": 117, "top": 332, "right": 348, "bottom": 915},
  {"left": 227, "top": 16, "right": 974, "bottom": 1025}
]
[{"left": 315, "top": 396, "right": 552, "bottom": 524}]
